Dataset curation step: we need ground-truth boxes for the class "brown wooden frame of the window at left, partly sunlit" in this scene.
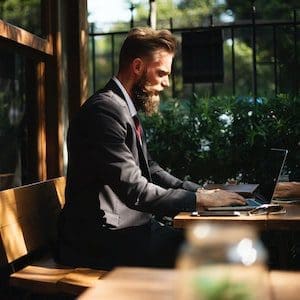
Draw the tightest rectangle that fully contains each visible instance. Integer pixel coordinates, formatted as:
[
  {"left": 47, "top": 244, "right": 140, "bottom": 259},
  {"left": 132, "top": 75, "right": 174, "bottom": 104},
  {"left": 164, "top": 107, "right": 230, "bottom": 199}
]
[{"left": 0, "top": 0, "right": 58, "bottom": 184}]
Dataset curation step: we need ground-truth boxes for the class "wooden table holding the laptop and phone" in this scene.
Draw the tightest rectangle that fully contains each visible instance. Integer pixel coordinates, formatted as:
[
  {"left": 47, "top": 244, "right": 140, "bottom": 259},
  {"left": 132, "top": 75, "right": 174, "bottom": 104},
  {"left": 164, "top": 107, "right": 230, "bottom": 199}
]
[{"left": 173, "top": 204, "right": 300, "bottom": 230}]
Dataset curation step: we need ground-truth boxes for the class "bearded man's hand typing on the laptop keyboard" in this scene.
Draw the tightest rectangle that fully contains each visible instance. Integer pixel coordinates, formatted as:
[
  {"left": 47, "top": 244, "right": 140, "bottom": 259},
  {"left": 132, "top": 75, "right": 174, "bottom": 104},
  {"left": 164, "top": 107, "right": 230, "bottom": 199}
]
[{"left": 196, "top": 189, "right": 246, "bottom": 209}]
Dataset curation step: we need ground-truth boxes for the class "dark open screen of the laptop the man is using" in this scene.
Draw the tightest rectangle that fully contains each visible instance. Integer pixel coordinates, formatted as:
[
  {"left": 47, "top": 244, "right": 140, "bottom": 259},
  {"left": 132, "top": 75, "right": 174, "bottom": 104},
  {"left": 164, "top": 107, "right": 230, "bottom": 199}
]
[{"left": 255, "top": 148, "right": 288, "bottom": 203}]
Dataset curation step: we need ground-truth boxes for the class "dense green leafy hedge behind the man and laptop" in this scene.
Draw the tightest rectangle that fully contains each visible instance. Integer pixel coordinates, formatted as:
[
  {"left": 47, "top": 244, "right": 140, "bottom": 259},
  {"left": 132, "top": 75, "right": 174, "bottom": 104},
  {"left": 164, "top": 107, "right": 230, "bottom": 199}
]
[{"left": 143, "top": 95, "right": 300, "bottom": 183}]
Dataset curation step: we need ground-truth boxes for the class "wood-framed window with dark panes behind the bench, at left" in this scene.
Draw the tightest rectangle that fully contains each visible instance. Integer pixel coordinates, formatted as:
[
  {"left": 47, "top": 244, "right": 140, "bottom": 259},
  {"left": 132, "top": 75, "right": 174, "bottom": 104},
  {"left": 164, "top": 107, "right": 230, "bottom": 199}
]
[{"left": 0, "top": 0, "right": 57, "bottom": 190}]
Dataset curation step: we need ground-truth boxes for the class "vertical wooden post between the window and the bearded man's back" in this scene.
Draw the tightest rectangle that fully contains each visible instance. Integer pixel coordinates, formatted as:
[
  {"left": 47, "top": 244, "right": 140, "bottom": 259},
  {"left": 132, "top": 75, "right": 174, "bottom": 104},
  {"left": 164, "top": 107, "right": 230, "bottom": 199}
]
[{"left": 44, "top": 0, "right": 63, "bottom": 178}]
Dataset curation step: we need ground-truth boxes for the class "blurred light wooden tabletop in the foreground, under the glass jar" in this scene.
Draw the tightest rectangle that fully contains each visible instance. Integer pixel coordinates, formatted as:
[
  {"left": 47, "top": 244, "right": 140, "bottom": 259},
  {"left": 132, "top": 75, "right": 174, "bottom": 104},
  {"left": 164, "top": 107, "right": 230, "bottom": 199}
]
[{"left": 78, "top": 268, "right": 300, "bottom": 300}]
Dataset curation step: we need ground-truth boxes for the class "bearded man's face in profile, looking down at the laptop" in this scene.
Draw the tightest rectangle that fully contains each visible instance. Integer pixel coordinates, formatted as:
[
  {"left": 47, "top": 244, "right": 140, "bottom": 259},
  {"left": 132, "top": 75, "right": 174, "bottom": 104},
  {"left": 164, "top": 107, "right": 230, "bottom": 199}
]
[{"left": 133, "top": 50, "right": 173, "bottom": 114}]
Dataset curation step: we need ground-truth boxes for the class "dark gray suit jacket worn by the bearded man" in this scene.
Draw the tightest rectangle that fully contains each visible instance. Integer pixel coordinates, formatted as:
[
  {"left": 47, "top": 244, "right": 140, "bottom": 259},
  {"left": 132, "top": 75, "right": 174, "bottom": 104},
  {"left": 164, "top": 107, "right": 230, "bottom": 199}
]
[{"left": 63, "top": 80, "right": 199, "bottom": 229}]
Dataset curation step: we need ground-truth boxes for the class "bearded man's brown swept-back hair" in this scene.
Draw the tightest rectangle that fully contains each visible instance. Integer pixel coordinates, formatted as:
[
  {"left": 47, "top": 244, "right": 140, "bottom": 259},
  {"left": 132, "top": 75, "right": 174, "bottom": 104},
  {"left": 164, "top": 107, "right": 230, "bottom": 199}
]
[{"left": 119, "top": 27, "right": 177, "bottom": 70}]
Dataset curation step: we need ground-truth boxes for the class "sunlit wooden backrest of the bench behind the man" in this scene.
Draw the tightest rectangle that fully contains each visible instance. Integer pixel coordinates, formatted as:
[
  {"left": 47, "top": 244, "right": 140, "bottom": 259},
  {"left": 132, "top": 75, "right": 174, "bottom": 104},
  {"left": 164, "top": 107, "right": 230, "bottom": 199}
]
[{"left": 0, "top": 177, "right": 65, "bottom": 266}]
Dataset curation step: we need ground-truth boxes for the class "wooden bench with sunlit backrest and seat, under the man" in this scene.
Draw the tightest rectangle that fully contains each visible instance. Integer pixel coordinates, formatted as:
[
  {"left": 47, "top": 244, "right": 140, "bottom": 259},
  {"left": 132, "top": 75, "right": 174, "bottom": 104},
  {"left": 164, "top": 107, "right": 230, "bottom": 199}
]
[{"left": 0, "top": 177, "right": 106, "bottom": 298}]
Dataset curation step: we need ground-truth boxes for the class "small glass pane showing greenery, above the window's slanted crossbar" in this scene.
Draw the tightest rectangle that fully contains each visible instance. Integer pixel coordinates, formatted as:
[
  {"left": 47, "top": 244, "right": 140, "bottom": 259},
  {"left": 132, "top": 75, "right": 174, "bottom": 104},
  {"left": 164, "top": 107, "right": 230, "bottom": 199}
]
[{"left": 0, "top": 0, "right": 43, "bottom": 36}]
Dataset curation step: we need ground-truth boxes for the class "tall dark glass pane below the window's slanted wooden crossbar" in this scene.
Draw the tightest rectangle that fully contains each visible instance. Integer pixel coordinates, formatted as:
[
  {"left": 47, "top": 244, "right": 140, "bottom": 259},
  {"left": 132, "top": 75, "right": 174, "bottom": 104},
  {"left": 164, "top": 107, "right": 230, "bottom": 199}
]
[{"left": 0, "top": 50, "right": 26, "bottom": 190}]
